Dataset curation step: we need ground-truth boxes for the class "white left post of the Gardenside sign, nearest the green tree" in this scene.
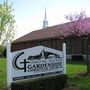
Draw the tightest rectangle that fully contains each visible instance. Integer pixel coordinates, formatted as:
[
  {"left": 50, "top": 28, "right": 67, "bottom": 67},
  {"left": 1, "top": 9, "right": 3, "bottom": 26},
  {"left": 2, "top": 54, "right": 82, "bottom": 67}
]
[{"left": 6, "top": 41, "right": 12, "bottom": 90}]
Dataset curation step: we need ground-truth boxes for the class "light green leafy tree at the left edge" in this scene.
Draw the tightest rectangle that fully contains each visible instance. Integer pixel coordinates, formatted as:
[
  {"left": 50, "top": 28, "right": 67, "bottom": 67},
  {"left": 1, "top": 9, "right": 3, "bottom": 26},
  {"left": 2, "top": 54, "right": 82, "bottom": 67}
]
[{"left": 0, "top": 0, "right": 15, "bottom": 52}]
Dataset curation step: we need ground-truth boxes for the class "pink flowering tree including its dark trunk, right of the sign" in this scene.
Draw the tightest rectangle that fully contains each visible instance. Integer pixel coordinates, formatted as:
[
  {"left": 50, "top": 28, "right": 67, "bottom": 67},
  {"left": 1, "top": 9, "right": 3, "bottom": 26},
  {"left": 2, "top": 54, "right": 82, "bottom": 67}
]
[{"left": 65, "top": 11, "right": 90, "bottom": 73}]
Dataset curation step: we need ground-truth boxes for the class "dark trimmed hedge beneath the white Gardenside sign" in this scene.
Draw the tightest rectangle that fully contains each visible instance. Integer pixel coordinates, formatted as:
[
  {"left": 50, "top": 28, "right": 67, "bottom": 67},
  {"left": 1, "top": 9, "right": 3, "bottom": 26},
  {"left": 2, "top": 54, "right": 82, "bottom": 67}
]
[{"left": 11, "top": 75, "right": 67, "bottom": 90}]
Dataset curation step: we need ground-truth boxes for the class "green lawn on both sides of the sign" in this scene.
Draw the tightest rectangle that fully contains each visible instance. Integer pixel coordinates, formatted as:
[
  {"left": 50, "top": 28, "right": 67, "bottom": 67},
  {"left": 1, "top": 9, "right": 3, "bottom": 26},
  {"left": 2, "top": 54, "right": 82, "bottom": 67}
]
[{"left": 0, "top": 58, "right": 90, "bottom": 90}]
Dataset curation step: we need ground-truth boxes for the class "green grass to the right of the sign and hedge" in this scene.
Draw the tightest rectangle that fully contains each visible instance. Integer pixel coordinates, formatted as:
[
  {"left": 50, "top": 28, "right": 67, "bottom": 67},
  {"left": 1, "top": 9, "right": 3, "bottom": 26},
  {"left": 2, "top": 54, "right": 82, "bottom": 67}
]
[{"left": 67, "top": 64, "right": 90, "bottom": 90}]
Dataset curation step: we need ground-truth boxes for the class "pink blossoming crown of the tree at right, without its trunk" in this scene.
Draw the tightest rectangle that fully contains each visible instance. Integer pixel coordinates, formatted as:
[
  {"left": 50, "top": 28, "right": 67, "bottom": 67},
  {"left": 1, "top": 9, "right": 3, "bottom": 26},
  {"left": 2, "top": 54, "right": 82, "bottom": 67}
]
[{"left": 65, "top": 11, "right": 90, "bottom": 36}]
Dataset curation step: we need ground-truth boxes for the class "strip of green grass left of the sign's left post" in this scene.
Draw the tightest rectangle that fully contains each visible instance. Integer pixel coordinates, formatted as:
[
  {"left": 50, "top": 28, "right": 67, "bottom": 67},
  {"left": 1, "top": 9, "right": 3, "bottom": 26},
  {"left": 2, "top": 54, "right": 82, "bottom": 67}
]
[{"left": 0, "top": 58, "right": 6, "bottom": 90}]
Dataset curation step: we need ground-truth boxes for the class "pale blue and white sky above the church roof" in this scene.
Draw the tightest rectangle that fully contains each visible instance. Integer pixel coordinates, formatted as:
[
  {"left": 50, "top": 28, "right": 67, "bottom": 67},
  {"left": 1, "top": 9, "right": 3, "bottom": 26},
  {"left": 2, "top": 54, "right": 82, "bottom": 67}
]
[{"left": 1, "top": 0, "right": 90, "bottom": 38}]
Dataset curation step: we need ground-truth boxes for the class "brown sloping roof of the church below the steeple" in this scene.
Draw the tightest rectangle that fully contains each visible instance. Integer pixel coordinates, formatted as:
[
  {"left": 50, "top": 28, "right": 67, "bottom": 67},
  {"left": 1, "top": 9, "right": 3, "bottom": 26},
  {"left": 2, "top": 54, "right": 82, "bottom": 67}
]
[{"left": 14, "top": 18, "right": 90, "bottom": 43}]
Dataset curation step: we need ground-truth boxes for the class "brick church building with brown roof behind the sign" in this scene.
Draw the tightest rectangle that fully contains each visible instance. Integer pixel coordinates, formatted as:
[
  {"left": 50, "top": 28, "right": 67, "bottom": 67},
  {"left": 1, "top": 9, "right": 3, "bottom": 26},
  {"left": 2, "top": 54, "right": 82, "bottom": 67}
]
[{"left": 12, "top": 18, "right": 90, "bottom": 58}]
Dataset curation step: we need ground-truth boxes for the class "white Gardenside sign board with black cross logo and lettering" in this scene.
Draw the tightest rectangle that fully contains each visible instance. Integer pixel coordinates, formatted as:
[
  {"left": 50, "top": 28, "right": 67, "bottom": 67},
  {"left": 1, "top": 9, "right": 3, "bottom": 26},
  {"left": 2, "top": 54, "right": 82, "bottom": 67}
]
[{"left": 7, "top": 45, "right": 66, "bottom": 89}]
